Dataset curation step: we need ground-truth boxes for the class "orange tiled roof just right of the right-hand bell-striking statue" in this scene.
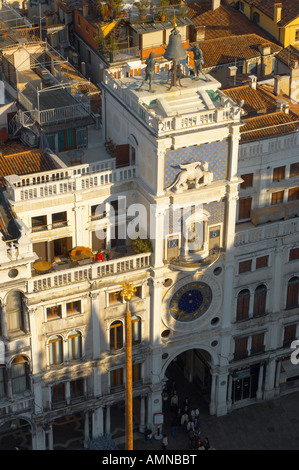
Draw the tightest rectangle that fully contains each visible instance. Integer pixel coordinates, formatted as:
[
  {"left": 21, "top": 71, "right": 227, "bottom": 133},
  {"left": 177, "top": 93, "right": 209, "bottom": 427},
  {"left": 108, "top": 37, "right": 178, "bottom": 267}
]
[{"left": 200, "top": 34, "right": 281, "bottom": 67}]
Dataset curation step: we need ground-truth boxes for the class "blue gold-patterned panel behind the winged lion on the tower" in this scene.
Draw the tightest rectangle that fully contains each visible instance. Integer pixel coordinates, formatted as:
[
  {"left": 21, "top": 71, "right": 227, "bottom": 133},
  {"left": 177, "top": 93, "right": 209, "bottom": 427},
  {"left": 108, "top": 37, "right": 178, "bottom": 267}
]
[{"left": 164, "top": 140, "right": 228, "bottom": 188}]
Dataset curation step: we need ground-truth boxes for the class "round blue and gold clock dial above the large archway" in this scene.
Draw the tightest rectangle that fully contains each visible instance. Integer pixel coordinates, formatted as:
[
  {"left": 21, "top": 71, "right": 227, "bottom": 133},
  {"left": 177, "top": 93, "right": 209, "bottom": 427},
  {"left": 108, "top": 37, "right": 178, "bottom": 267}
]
[{"left": 169, "top": 282, "right": 212, "bottom": 322}]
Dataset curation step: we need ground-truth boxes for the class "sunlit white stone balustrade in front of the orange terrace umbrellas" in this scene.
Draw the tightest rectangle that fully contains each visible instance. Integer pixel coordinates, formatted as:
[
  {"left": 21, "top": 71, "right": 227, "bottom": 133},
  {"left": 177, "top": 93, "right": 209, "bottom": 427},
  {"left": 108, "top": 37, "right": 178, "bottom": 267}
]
[{"left": 27, "top": 253, "right": 151, "bottom": 293}]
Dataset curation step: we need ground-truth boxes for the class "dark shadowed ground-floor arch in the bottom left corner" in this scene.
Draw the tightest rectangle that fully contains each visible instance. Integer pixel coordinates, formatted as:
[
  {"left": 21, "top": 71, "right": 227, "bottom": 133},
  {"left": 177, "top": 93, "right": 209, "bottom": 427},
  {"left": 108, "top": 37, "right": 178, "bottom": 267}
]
[{"left": 0, "top": 418, "right": 32, "bottom": 451}]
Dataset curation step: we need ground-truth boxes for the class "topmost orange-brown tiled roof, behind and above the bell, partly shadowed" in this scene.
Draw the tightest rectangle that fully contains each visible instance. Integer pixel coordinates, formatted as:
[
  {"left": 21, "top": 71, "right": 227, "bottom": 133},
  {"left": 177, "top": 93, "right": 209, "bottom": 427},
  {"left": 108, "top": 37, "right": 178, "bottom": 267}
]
[{"left": 188, "top": 0, "right": 276, "bottom": 40}]
